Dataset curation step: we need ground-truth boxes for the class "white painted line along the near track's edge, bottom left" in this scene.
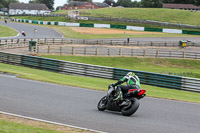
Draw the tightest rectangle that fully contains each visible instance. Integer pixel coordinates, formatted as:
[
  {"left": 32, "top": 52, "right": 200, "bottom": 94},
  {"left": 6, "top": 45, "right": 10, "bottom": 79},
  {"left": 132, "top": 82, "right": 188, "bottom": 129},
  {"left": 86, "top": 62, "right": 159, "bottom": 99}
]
[{"left": 0, "top": 111, "right": 106, "bottom": 133}]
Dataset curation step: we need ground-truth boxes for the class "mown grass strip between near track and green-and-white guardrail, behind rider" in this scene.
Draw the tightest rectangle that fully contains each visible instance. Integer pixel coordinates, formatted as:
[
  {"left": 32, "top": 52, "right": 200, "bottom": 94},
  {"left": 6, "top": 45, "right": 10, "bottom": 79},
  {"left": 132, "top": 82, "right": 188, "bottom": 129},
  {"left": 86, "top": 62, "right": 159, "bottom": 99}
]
[{"left": 0, "top": 63, "right": 200, "bottom": 103}]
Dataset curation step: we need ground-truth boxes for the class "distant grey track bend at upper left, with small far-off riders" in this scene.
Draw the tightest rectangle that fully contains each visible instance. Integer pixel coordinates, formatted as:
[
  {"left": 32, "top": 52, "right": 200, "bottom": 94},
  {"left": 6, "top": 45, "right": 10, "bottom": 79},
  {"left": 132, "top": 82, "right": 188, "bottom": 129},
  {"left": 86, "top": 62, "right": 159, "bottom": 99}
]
[{"left": 0, "top": 21, "right": 63, "bottom": 39}]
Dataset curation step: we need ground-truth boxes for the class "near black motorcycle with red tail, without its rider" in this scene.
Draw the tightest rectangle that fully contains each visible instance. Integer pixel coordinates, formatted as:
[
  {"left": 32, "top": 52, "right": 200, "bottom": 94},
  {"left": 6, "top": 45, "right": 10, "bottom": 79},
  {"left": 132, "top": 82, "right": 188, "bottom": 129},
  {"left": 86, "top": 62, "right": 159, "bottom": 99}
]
[{"left": 97, "top": 85, "right": 146, "bottom": 116}]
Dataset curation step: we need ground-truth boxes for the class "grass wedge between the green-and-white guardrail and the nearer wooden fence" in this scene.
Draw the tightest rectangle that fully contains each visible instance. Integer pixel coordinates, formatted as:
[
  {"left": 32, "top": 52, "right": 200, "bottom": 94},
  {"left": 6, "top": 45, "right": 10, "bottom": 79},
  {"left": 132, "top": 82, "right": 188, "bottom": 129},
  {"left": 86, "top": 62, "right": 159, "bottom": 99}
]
[{"left": 39, "top": 55, "right": 200, "bottom": 78}]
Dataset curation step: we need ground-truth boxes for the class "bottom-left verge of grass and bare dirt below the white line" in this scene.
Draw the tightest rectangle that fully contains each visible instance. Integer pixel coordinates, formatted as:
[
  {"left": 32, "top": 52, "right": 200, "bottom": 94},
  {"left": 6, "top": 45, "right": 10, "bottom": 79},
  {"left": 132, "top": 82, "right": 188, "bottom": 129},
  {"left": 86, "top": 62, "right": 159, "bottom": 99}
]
[{"left": 0, "top": 114, "right": 92, "bottom": 133}]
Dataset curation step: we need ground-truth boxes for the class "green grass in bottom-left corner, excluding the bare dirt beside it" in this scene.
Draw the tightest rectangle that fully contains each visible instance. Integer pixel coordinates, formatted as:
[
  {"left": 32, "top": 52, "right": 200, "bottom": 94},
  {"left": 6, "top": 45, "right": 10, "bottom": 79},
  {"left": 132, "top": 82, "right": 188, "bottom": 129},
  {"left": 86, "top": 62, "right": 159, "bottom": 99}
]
[{"left": 0, "top": 120, "right": 61, "bottom": 133}]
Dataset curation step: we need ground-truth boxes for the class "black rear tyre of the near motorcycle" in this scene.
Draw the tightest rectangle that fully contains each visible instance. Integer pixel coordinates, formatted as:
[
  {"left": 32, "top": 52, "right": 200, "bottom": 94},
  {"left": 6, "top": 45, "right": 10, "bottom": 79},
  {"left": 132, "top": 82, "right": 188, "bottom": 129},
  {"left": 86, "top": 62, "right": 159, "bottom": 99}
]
[{"left": 121, "top": 98, "right": 140, "bottom": 116}]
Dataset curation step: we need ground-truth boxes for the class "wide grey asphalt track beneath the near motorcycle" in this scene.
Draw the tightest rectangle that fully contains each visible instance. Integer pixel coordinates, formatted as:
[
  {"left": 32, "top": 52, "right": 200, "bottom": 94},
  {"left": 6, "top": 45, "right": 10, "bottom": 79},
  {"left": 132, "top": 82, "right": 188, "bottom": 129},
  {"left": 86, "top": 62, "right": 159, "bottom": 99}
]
[{"left": 0, "top": 75, "right": 200, "bottom": 133}]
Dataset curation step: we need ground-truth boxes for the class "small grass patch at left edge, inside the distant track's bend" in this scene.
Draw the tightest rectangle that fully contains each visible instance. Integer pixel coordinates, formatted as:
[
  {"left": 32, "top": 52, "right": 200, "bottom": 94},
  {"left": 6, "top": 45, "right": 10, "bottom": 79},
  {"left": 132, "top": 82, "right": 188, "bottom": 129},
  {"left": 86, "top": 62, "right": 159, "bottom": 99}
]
[{"left": 0, "top": 25, "right": 17, "bottom": 37}]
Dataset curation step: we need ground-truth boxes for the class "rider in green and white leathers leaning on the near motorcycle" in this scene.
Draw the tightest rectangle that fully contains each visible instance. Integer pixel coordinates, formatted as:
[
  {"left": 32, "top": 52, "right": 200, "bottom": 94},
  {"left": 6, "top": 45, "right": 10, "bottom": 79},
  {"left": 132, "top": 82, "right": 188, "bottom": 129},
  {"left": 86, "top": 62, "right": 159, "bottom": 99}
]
[{"left": 112, "top": 72, "right": 141, "bottom": 105}]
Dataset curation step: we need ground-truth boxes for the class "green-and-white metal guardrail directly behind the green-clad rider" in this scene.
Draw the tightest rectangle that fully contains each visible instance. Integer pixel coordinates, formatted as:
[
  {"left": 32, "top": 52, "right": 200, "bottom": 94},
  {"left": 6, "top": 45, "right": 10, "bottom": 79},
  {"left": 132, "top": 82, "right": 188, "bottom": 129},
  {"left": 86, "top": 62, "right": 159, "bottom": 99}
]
[{"left": 0, "top": 52, "right": 200, "bottom": 92}]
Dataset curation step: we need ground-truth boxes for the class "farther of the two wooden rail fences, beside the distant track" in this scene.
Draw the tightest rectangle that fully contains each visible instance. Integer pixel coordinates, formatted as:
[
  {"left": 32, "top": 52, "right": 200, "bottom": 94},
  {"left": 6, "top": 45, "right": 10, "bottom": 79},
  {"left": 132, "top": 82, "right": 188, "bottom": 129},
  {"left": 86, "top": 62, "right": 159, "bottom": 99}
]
[{"left": 0, "top": 38, "right": 200, "bottom": 48}]
